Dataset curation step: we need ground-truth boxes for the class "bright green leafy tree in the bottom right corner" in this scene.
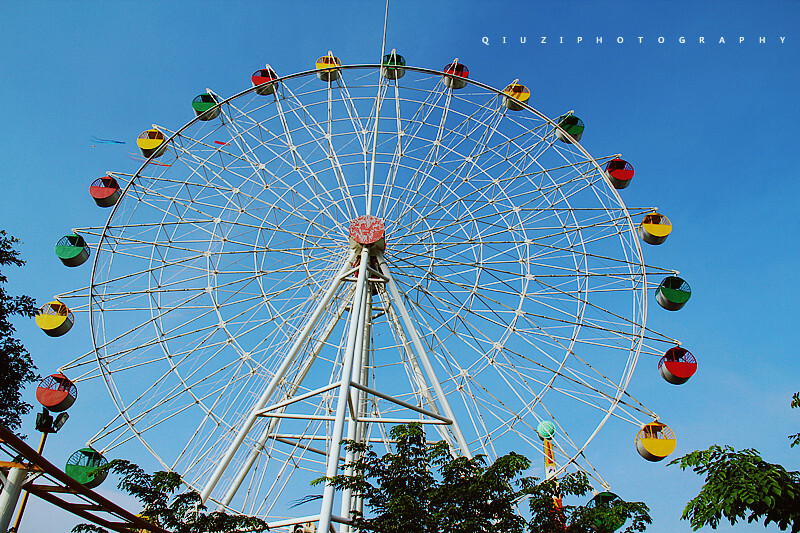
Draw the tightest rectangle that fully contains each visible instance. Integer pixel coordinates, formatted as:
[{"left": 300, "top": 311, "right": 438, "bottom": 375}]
[{"left": 670, "top": 393, "right": 800, "bottom": 533}]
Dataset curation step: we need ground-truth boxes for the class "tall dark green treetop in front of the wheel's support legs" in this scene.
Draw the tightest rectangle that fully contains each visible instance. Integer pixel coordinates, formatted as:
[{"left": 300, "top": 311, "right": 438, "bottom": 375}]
[{"left": 317, "top": 424, "right": 530, "bottom": 533}]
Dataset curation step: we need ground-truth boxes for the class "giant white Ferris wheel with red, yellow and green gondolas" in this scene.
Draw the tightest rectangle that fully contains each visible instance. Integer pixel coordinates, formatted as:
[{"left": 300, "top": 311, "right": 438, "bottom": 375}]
[{"left": 47, "top": 52, "right": 691, "bottom": 530}]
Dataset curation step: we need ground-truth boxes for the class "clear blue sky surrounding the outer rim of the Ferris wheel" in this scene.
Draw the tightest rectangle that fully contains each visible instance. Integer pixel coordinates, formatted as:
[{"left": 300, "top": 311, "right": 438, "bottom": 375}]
[{"left": 0, "top": 0, "right": 800, "bottom": 533}]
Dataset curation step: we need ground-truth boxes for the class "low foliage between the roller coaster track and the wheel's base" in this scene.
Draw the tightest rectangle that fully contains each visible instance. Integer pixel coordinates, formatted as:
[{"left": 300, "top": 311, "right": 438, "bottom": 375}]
[{"left": 72, "top": 459, "right": 267, "bottom": 533}]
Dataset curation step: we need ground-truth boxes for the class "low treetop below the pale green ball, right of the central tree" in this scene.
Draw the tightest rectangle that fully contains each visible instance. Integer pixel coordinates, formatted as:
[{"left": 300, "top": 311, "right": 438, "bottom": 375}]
[{"left": 523, "top": 472, "right": 653, "bottom": 533}]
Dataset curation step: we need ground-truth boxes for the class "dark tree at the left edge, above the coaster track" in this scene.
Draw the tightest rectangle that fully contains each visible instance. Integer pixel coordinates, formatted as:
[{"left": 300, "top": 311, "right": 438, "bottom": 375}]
[{"left": 0, "top": 230, "right": 40, "bottom": 431}]
